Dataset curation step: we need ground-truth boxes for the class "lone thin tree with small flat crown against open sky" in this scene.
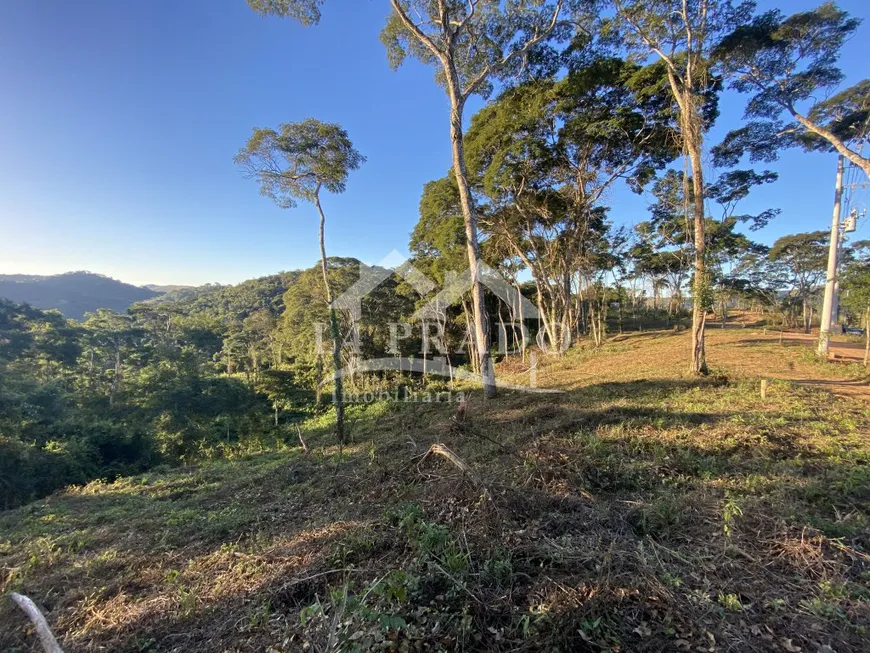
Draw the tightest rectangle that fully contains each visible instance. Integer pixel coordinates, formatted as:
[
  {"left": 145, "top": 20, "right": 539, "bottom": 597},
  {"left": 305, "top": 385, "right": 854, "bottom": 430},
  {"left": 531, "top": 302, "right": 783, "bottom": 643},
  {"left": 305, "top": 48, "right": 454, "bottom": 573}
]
[{"left": 235, "top": 118, "right": 365, "bottom": 442}]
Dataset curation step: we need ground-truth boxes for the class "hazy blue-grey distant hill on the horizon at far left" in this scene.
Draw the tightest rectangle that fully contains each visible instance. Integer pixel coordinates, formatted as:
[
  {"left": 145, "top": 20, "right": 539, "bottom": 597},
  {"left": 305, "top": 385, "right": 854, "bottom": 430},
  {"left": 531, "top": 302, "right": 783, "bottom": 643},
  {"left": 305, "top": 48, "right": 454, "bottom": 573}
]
[{"left": 0, "top": 272, "right": 162, "bottom": 320}]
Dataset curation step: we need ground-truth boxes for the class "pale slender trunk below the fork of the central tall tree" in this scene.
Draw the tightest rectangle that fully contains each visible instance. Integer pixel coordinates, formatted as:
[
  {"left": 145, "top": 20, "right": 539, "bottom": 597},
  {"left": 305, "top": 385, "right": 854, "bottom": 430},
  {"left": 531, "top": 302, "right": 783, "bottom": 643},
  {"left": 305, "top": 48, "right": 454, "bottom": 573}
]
[{"left": 445, "top": 77, "right": 496, "bottom": 398}]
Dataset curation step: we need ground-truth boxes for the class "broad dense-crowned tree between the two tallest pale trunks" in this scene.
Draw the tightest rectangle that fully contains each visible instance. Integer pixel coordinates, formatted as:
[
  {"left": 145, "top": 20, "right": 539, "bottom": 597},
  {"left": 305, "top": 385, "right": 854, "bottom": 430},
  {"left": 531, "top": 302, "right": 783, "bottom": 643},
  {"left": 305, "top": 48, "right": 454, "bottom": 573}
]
[{"left": 466, "top": 58, "right": 678, "bottom": 351}]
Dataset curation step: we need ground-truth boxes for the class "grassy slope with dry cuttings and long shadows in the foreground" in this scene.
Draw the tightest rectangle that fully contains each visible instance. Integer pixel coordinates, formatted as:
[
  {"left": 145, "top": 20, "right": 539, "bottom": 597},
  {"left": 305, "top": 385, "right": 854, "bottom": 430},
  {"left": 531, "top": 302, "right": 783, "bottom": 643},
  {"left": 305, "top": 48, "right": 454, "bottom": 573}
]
[{"left": 0, "top": 330, "right": 870, "bottom": 653}]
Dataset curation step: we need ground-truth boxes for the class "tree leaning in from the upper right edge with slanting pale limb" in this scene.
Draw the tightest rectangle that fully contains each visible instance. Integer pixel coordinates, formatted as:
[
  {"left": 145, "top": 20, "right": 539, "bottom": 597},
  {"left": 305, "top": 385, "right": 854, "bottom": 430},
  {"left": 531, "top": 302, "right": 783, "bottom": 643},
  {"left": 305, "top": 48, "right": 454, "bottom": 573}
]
[{"left": 715, "top": 2, "right": 870, "bottom": 176}]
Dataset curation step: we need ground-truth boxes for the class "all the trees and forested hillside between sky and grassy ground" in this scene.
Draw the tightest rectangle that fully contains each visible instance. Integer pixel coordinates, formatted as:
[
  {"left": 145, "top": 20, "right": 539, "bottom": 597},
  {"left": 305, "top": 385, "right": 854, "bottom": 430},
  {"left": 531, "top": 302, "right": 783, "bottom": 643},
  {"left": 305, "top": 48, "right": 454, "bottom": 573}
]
[{"left": 0, "top": 2, "right": 870, "bottom": 507}]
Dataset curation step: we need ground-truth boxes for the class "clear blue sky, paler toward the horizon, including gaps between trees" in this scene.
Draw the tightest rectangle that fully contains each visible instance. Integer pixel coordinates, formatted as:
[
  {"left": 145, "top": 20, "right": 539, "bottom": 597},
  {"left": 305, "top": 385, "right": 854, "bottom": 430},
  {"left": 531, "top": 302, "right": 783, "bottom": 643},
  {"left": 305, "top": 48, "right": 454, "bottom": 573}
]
[{"left": 0, "top": 0, "right": 870, "bottom": 284}]
